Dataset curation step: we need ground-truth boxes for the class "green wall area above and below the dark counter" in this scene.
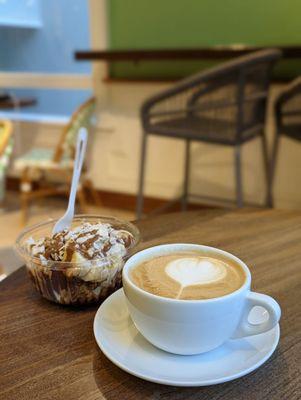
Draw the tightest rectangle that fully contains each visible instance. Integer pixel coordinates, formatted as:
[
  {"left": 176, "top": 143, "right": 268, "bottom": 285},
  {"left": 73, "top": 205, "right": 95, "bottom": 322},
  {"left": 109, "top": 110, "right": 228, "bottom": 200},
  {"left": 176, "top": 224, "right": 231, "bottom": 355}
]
[{"left": 108, "top": 0, "right": 301, "bottom": 78}]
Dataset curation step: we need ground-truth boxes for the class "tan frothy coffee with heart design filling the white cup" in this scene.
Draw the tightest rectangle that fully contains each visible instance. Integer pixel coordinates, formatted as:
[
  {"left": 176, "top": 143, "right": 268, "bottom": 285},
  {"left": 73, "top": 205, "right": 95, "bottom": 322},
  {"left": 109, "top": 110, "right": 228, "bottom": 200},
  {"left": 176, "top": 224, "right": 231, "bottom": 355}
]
[{"left": 130, "top": 251, "right": 246, "bottom": 300}]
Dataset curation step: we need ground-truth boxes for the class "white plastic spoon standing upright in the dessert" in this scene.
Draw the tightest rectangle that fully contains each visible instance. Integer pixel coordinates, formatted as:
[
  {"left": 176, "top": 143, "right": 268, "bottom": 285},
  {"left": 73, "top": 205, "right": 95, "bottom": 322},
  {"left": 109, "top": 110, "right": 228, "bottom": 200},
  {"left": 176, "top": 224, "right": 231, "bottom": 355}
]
[{"left": 52, "top": 128, "right": 88, "bottom": 235}]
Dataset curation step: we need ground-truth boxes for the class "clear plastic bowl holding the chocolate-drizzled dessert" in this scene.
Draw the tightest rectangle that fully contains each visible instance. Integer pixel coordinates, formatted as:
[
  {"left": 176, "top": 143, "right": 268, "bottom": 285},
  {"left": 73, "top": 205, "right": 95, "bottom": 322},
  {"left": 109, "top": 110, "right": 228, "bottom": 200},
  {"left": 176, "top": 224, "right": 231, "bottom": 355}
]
[{"left": 16, "top": 214, "right": 140, "bottom": 305}]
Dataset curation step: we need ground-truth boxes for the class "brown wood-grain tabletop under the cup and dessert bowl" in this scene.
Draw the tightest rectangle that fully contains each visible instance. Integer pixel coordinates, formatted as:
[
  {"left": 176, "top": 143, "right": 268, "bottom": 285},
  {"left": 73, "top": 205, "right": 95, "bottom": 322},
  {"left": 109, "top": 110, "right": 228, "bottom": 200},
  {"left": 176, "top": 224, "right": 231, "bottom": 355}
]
[{"left": 0, "top": 210, "right": 301, "bottom": 400}]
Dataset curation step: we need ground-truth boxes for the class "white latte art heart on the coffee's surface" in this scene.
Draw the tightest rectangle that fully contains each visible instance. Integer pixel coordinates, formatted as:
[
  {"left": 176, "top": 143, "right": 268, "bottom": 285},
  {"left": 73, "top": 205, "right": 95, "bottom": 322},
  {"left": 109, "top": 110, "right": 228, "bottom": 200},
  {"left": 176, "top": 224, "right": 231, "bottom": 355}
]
[{"left": 165, "top": 257, "right": 226, "bottom": 288}]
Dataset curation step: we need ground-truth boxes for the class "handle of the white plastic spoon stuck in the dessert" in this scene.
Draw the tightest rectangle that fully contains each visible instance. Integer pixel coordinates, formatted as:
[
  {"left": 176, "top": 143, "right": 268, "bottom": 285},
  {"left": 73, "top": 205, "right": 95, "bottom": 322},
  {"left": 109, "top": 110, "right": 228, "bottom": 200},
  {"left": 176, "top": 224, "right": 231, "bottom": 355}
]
[{"left": 67, "top": 128, "right": 88, "bottom": 218}]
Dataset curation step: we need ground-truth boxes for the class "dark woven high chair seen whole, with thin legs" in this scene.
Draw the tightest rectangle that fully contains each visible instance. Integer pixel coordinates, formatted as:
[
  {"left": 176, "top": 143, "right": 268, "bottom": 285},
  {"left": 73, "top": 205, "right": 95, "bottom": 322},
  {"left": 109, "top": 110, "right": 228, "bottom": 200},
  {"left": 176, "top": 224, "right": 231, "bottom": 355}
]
[{"left": 137, "top": 49, "right": 281, "bottom": 218}]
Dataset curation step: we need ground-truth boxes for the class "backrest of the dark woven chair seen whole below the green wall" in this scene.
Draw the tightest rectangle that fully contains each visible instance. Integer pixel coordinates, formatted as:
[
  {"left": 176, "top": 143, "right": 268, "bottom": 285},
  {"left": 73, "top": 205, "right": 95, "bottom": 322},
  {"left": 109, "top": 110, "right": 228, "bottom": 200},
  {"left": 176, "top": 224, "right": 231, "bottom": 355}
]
[{"left": 141, "top": 49, "right": 281, "bottom": 138}]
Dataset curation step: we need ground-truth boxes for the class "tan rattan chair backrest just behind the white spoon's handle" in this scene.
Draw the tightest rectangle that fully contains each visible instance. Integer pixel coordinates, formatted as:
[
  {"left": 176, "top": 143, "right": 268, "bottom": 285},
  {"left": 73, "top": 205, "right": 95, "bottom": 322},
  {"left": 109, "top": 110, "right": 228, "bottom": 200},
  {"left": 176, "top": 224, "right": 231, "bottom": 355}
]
[{"left": 53, "top": 97, "right": 96, "bottom": 162}]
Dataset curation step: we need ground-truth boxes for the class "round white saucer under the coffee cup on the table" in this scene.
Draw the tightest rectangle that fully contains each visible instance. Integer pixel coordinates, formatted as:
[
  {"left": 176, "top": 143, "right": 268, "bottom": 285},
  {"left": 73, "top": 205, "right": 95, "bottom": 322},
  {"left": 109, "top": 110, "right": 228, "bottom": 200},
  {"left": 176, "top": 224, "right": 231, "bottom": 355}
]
[{"left": 94, "top": 289, "right": 280, "bottom": 386}]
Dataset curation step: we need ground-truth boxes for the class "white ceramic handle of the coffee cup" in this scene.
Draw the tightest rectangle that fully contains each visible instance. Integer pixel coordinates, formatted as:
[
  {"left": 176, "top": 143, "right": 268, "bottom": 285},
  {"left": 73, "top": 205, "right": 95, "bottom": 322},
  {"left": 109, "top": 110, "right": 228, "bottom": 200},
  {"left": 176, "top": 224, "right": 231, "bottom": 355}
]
[{"left": 231, "top": 292, "right": 281, "bottom": 339}]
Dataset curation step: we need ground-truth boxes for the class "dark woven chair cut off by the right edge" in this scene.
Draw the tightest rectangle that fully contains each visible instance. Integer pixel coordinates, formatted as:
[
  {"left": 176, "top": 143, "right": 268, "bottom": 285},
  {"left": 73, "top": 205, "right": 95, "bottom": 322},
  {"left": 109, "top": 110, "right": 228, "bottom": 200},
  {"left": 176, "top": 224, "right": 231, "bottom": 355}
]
[{"left": 268, "top": 77, "right": 301, "bottom": 207}]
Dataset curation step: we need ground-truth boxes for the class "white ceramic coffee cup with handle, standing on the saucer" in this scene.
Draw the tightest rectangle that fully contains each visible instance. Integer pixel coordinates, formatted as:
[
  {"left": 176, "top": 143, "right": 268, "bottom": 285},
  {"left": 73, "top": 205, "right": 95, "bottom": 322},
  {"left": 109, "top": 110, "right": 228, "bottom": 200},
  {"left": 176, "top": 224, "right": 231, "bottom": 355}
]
[{"left": 122, "top": 244, "right": 281, "bottom": 355}]
